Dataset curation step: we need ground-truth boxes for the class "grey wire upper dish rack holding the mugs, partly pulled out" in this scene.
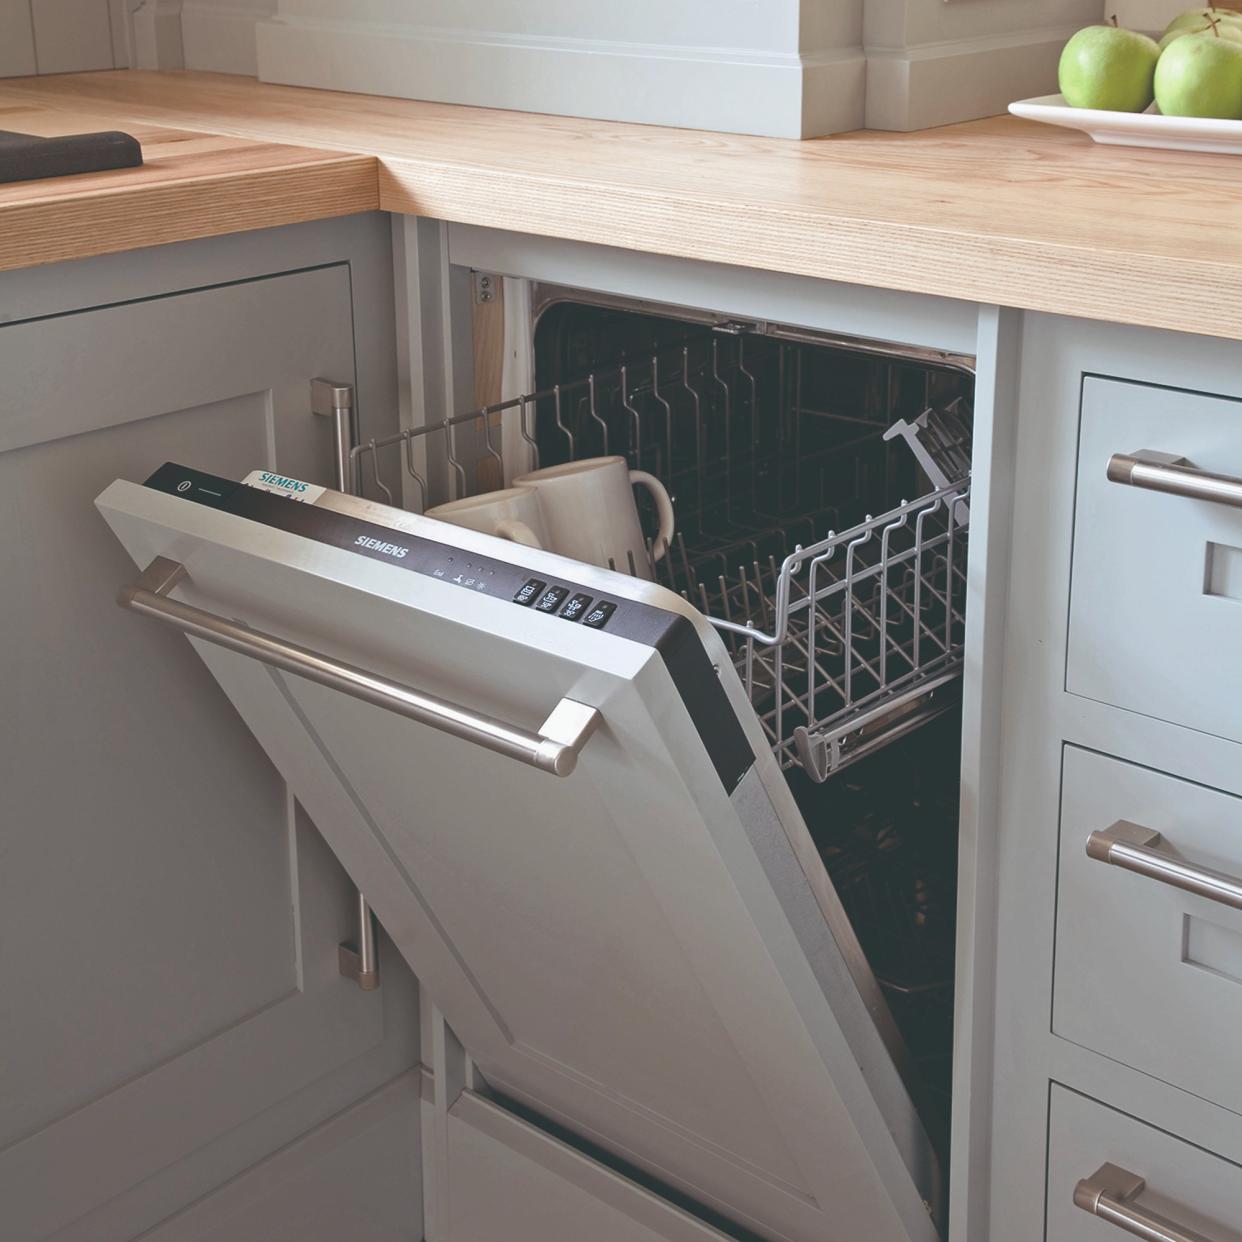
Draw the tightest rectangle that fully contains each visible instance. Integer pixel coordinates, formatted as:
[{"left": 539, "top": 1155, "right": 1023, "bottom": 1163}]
[{"left": 353, "top": 329, "right": 971, "bottom": 781}]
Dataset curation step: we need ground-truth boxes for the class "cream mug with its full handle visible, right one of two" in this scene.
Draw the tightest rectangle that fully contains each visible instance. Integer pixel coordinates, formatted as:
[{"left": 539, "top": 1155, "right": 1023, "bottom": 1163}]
[{"left": 513, "top": 457, "right": 673, "bottom": 578}]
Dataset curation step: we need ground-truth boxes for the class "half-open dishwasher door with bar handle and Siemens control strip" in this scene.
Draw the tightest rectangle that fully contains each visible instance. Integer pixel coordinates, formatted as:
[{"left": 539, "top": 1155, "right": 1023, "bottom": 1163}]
[{"left": 97, "top": 465, "right": 939, "bottom": 1242}]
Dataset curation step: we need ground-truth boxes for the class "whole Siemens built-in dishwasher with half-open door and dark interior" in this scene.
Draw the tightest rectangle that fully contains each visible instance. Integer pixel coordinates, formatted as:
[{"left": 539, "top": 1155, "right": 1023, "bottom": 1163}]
[{"left": 97, "top": 286, "right": 974, "bottom": 1242}]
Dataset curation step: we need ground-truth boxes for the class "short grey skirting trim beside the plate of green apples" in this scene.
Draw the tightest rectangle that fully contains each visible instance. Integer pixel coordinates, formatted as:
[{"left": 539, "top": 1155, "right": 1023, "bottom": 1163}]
[{"left": 866, "top": 26, "right": 1077, "bottom": 132}]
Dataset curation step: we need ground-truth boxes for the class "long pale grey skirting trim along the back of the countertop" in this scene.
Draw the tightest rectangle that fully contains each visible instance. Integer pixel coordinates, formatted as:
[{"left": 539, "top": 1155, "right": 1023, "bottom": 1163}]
[{"left": 257, "top": 17, "right": 866, "bottom": 138}]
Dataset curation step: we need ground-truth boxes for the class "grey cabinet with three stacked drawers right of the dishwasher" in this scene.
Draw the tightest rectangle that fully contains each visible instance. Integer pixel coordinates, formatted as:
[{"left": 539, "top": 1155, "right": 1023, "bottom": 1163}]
[{"left": 988, "top": 314, "right": 1242, "bottom": 1242}]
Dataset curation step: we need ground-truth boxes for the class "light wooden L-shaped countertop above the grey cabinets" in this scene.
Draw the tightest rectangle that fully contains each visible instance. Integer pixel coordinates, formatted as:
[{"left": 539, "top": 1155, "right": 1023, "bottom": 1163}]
[{"left": 0, "top": 71, "right": 1242, "bottom": 340}]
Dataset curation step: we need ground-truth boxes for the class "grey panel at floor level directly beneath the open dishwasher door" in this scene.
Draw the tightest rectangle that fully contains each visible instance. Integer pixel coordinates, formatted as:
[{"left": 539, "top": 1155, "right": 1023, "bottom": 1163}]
[{"left": 445, "top": 1092, "right": 729, "bottom": 1242}]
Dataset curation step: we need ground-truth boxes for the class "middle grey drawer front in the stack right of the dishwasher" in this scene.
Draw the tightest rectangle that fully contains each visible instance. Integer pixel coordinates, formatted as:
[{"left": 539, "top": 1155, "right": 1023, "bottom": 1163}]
[{"left": 1052, "top": 746, "right": 1242, "bottom": 1113}]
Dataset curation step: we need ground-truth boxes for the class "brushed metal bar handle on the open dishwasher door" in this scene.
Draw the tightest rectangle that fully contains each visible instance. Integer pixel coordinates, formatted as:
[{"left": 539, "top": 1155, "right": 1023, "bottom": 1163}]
[{"left": 117, "top": 556, "right": 600, "bottom": 776}]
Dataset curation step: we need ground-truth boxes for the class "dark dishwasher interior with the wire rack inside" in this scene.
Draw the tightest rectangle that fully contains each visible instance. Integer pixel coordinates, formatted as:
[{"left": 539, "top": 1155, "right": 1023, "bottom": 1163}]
[{"left": 353, "top": 286, "right": 974, "bottom": 1151}]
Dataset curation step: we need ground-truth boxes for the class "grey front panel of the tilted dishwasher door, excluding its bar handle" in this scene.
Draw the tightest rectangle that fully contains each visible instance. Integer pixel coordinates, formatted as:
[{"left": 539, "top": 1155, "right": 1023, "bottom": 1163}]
[{"left": 99, "top": 483, "right": 935, "bottom": 1242}]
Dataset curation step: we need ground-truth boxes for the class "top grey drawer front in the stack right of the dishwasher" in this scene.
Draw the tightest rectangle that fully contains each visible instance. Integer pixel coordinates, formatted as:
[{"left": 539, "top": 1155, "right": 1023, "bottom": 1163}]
[{"left": 1066, "top": 376, "right": 1242, "bottom": 740}]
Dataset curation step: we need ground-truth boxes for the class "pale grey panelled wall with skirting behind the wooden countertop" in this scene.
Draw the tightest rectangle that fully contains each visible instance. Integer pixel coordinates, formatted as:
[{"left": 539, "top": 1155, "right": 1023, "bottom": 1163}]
[{"left": 162, "top": 0, "right": 1100, "bottom": 138}]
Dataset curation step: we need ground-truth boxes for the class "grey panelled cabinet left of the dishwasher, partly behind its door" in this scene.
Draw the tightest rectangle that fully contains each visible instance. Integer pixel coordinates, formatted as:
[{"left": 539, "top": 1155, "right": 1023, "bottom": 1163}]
[{"left": 0, "top": 216, "right": 421, "bottom": 1242}]
